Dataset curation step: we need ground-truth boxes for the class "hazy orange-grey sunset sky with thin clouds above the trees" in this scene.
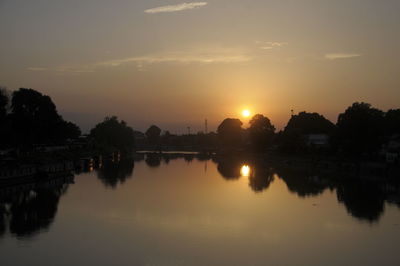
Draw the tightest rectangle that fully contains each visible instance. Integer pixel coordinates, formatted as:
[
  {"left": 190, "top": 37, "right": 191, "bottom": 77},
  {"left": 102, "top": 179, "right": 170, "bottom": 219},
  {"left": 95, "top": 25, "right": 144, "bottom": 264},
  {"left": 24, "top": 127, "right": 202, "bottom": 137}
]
[{"left": 0, "top": 0, "right": 400, "bottom": 134}]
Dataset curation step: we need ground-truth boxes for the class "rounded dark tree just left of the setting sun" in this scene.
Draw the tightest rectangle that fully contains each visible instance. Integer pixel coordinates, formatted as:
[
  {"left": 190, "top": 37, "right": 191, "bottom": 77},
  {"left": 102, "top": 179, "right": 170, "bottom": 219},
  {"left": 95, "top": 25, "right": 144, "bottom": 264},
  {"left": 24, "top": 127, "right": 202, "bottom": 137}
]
[{"left": 217, "top": 118, "right": 243, "bottom": 147}]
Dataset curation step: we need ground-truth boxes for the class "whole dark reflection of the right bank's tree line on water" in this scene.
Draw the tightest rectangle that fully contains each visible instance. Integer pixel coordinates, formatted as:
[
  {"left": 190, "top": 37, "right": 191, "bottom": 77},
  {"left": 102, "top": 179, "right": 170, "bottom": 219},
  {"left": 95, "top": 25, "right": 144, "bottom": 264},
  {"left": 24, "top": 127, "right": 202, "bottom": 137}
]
[{"left": 213, "top": 156, "right": 400, "bottom": 222}]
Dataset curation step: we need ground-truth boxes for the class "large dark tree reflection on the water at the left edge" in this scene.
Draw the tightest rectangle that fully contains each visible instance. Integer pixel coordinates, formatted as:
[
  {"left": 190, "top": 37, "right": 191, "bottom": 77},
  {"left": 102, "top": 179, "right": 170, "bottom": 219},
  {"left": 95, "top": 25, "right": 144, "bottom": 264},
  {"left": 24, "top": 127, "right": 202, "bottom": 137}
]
[{"left": 0, "top": 179, "right": 68, "bottom": 238}]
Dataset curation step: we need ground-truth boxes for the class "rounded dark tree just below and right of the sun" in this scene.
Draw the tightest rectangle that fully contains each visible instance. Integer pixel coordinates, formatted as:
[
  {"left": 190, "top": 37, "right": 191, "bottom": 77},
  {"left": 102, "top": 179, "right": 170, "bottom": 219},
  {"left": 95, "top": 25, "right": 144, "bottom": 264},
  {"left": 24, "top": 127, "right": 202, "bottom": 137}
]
[{"left": 249, "top": 114, "right": 275, "bottom": 151}]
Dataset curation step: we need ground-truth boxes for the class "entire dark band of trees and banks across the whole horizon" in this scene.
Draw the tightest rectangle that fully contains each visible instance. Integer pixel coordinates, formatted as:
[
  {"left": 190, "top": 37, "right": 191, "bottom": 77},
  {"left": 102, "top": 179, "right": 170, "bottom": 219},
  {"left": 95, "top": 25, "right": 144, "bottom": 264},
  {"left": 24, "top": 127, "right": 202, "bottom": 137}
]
[{"left": 0, "top": 88, "right": 400, "bottom": 181}]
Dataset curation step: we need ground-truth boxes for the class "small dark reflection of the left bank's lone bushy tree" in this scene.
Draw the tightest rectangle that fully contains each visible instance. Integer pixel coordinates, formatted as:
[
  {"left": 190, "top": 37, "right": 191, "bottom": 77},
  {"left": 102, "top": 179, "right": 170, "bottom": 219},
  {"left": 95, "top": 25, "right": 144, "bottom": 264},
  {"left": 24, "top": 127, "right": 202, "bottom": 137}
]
[{"left": 97, "top": 158, "right": 134, "bottom": 188}]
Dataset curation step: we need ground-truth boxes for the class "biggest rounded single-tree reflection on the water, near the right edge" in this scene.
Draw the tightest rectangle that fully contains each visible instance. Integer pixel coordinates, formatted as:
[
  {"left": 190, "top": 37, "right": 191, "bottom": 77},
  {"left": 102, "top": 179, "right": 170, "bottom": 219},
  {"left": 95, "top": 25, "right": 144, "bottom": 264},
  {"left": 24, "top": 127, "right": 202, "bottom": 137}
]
[{"left": 336, "top": 180, "right": 385, "bottom": 222}]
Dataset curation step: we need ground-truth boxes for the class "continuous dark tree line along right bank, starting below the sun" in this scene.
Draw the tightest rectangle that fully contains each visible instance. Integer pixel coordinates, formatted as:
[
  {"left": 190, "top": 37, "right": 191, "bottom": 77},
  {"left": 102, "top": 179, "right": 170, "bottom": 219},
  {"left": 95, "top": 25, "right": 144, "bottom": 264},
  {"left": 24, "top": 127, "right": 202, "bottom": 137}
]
[{"left": 217, "top": 102, "right": 400, "bottom": 156}]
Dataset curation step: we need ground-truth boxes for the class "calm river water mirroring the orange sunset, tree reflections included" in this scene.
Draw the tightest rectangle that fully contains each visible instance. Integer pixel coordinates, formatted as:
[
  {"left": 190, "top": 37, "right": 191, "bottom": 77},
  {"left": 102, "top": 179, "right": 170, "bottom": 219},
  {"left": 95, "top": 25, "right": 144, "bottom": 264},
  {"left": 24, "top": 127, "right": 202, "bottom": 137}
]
[{"left": 0, "top": 155, "right": 400, "bottom": 266}]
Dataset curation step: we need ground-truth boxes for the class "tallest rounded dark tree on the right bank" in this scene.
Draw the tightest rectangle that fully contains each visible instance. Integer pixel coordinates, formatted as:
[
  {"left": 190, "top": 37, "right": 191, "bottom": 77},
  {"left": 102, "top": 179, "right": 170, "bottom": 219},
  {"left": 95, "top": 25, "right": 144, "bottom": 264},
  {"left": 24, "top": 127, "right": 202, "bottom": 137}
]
[{"left": 337, "top": 102, "right": 384, "bottom": 154}]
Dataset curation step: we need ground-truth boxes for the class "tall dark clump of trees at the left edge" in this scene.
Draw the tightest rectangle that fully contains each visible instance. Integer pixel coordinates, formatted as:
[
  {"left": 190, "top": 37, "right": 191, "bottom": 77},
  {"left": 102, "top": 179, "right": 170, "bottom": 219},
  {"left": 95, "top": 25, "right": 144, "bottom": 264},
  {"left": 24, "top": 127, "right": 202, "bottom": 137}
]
[{"left": 0, "top": 88, "right": 81, "bottom": 149}]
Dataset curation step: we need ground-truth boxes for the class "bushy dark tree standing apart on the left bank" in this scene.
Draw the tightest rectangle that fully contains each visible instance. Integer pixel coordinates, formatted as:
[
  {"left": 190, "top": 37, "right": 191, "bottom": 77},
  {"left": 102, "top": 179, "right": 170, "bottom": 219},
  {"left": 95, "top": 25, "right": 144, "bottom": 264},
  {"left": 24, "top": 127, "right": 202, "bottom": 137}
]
[{"left": 90, "top": 116, "right": 135, "bottom": 152}]
